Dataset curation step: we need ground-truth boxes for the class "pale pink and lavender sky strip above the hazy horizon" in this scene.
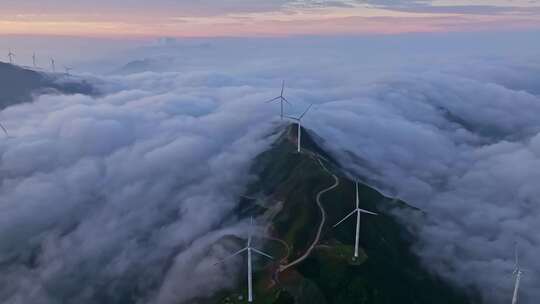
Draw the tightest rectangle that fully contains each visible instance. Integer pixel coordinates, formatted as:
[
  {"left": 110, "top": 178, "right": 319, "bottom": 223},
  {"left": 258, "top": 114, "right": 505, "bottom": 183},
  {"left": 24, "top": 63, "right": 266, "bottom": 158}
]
[{"left": 0, "top": 0, "right": 540, "bottom": 38}]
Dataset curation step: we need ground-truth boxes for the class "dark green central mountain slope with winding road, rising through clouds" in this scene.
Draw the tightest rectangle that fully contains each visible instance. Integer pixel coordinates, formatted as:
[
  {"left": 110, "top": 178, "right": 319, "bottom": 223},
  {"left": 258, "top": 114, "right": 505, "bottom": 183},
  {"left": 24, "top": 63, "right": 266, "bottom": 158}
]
[{"left": 215, "top": 126, "right": 478, "bottom": 304}]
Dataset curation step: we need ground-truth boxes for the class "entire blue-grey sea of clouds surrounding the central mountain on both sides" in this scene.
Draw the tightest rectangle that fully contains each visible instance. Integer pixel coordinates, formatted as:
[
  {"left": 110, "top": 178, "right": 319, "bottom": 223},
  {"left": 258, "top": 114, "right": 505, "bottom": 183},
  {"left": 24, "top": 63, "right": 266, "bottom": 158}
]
[{"left": 0, "top": 34, "right": 540, "bottom": 304}]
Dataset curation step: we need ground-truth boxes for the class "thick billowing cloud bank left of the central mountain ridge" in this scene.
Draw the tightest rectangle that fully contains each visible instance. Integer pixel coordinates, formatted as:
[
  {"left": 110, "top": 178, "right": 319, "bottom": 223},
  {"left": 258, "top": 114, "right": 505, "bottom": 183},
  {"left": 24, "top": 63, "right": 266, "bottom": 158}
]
[{"left": 0, "top": 73, "right": 284, "bottom": 303}]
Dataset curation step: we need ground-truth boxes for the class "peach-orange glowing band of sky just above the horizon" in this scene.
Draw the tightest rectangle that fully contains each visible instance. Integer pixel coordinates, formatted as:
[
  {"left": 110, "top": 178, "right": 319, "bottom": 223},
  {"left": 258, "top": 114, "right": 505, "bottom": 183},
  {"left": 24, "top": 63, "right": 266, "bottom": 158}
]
[{"left": 0, "top": 7, "right": 540, "bottom": 37}]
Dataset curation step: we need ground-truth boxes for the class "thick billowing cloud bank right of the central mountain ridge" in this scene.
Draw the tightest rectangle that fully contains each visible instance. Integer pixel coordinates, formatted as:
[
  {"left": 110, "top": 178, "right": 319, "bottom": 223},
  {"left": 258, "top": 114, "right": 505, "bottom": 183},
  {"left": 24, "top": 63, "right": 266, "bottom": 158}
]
[{"left": 311, "top": 70, "right": 540, "bottom": 303}]
